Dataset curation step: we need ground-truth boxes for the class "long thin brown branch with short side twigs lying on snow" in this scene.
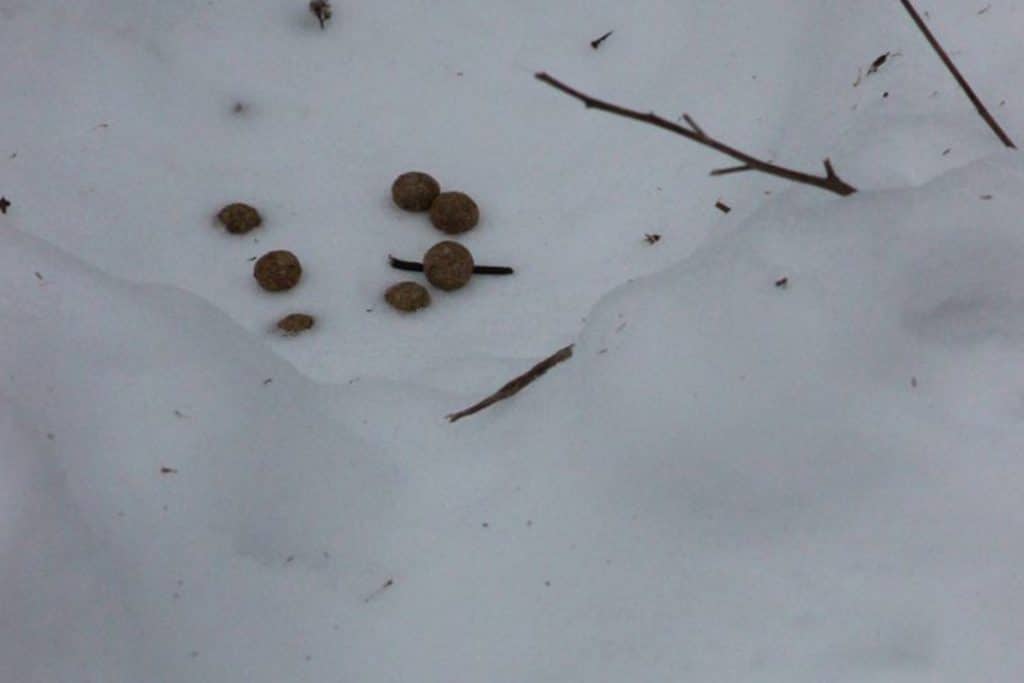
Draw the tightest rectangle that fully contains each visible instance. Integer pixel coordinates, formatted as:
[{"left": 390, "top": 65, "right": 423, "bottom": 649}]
[{"left": 536, "top": 73, "right": 857, "bottom": 197}]
